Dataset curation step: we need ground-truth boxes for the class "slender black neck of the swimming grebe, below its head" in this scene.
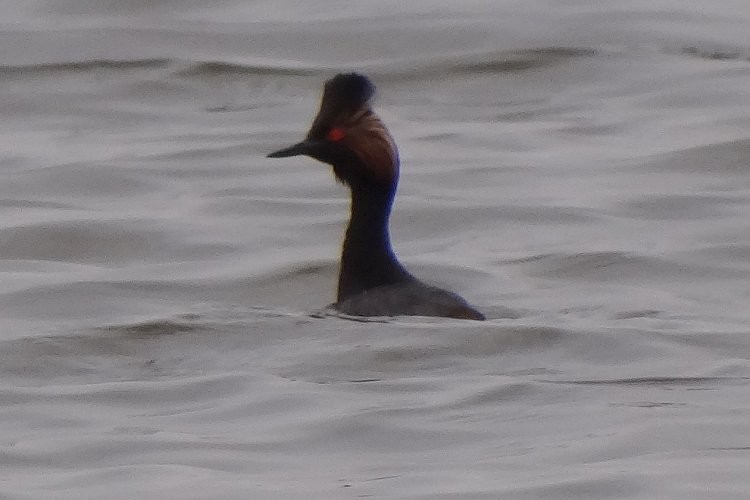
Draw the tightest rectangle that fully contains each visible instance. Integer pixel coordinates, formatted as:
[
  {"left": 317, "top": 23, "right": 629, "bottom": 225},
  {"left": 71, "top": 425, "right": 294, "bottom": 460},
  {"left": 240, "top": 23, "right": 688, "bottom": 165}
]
[{"left": 337, "top": 183, "right": 411, "bottom": 302}]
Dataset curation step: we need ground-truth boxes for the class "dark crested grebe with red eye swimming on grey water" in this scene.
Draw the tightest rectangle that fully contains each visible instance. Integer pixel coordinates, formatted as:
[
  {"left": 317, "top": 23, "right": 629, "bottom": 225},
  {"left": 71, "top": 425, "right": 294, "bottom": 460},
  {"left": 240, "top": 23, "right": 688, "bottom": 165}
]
[{"left": 268, "top": 73, "right": 485, "bottom": 320}]
